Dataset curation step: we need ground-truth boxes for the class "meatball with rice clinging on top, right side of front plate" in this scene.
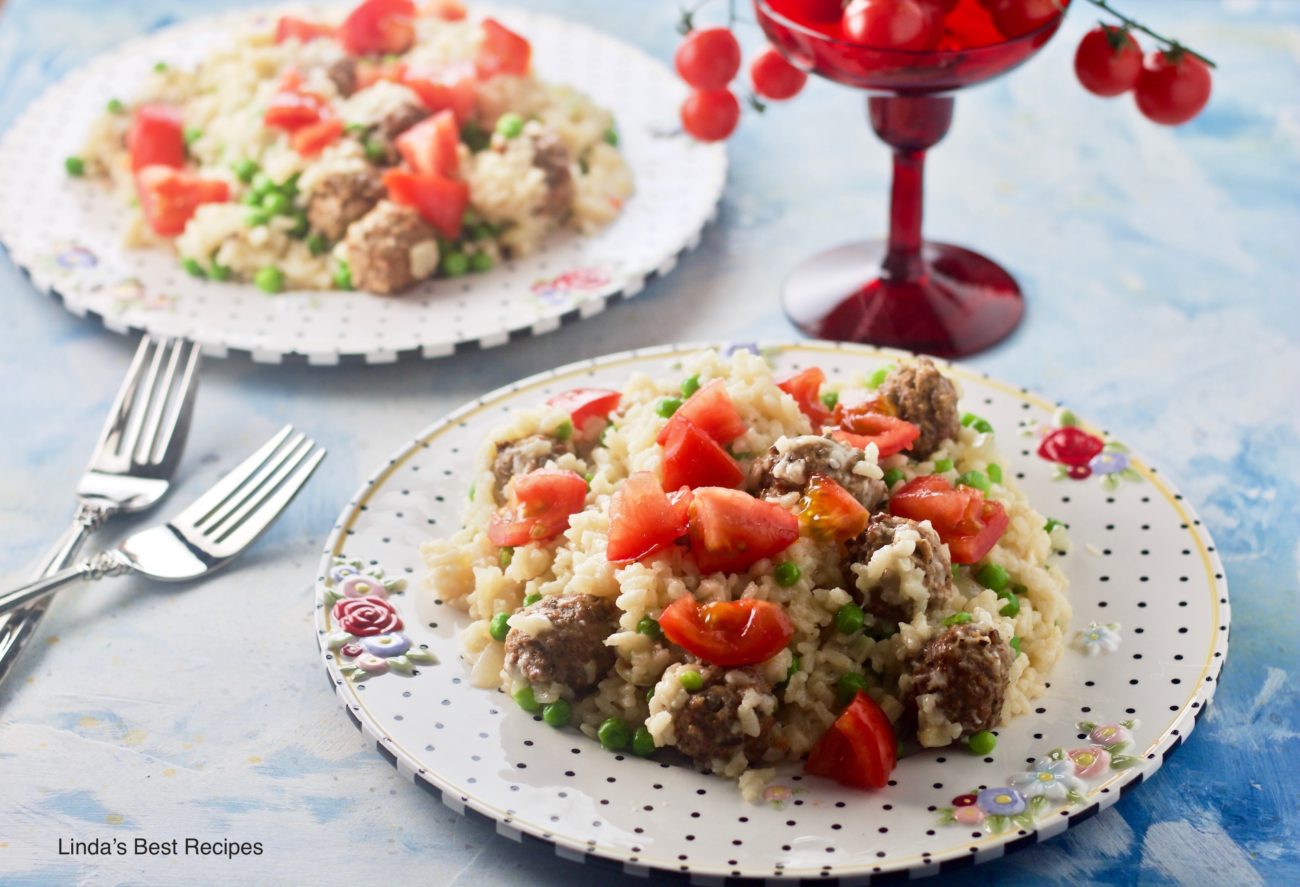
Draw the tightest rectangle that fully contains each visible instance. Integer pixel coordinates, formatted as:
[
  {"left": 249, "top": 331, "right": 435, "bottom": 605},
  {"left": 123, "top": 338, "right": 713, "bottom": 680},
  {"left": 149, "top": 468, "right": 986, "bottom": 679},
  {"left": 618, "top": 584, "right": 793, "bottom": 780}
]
[{"left": 844, "top": 514, "right": 956, "bottom": 624}]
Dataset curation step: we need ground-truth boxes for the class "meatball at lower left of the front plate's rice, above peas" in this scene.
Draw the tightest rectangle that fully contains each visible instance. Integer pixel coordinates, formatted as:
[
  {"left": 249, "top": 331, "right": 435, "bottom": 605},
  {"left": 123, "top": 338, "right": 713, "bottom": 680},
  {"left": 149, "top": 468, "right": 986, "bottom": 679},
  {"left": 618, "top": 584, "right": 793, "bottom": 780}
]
[{"left": 506, "top": 594, "right": 619, "bottom": 693}]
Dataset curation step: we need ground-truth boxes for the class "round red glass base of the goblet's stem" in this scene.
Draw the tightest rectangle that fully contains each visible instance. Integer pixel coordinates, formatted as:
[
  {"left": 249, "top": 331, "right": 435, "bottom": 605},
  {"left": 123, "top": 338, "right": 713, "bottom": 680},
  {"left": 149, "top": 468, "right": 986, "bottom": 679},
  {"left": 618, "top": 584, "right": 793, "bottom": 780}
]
[{"left": 781, "top": 241, "right": 1024, "bottom": 358}]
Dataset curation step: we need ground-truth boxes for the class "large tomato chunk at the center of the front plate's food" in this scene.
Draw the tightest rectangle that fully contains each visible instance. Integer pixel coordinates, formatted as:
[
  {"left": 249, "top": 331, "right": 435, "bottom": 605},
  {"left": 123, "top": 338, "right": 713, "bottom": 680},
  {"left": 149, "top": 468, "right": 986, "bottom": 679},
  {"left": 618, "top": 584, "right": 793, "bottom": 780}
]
[{"left": 690, "top": 486, "right": 800, "bottom": 574}]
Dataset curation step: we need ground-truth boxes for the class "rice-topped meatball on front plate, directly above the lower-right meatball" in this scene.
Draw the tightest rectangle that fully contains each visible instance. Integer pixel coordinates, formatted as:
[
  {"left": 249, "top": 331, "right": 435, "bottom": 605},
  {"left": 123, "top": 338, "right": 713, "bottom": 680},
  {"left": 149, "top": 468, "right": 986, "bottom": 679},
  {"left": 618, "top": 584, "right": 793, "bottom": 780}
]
[{"left": 844, "top": 514, "right": 954, "bottom": 624}]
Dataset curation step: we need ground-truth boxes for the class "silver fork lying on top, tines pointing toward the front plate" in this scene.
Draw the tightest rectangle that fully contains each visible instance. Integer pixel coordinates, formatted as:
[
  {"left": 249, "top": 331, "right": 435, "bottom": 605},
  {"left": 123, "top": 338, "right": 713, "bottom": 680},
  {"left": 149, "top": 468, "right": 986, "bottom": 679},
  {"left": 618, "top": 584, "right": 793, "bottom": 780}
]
[{"left": 0, "top": 425, "right": 325, "bottom": 613}]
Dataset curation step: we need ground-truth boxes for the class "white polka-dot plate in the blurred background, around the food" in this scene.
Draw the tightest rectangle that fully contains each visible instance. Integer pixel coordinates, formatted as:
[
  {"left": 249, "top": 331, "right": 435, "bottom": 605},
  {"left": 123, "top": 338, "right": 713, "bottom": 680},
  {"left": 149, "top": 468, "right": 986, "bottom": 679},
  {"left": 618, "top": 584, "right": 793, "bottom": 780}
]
[{"left": 0, "top": 4, "right": 727, "bottom": 364}]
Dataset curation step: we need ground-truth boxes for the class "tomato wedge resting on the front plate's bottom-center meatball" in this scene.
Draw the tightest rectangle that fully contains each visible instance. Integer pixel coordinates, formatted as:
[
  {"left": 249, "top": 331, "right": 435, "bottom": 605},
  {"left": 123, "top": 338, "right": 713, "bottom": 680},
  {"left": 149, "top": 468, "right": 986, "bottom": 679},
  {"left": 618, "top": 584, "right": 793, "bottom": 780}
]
[{"left": 659, "top": 597, "right": 794, "bottom": 667}]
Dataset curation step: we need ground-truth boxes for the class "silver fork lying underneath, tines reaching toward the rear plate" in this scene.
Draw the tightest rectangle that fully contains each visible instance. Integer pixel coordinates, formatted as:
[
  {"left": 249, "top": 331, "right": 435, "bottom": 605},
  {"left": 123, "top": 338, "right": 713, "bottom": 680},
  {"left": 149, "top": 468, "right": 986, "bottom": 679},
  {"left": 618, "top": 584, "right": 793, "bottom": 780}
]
[{"left": 0, "top": 336, "right": 200, "bottom": 682}]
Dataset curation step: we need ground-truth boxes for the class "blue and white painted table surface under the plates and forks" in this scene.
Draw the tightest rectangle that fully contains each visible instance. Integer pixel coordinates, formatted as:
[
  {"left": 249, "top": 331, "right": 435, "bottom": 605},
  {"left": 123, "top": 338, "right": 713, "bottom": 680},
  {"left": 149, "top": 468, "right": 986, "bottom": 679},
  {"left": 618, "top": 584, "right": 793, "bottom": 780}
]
[{"left": 0, "top": 0, "right": 1300, "bottom": 886}]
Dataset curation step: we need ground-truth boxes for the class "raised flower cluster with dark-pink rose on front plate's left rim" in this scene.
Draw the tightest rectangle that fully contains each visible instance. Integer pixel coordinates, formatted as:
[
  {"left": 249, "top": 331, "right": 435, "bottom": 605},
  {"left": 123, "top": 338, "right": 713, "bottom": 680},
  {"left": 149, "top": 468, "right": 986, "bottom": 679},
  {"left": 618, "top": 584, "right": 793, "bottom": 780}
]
[{"left": 325, "top": 558, "right": 437, "bottom": 683}]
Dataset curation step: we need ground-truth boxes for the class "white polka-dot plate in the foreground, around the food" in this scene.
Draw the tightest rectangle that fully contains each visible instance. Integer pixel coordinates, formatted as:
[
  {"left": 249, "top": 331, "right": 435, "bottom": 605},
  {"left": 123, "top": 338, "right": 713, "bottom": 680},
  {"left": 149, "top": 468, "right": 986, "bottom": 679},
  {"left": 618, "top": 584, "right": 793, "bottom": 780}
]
[{"left": 316, "top": 343, "right": 1229, "bottom": 883}]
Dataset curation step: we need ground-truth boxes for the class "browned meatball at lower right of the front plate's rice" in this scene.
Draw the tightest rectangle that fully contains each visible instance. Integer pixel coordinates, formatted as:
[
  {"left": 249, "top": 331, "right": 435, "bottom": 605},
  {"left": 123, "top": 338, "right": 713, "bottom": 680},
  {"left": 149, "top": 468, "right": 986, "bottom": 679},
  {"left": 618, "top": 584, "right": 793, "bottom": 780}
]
[{"left": 911, "top": 624, "right": 1014, "bottom": 748}]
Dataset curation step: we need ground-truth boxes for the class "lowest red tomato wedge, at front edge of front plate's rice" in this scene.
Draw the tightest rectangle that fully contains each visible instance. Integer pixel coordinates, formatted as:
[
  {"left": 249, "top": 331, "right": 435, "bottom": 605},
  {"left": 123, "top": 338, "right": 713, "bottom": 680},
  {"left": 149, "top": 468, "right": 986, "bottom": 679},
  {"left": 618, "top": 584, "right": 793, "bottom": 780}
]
[{"left": 803, "top": 691, "right": 898, "bottom": 788}]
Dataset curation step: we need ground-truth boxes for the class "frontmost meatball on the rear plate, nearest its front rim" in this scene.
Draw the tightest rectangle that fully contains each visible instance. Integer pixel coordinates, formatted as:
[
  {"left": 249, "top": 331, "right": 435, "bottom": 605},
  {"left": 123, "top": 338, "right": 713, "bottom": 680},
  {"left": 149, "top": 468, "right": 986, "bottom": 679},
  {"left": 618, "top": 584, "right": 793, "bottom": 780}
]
[{"left": 343, "top": 200, "right": 438, "bottom": 294}]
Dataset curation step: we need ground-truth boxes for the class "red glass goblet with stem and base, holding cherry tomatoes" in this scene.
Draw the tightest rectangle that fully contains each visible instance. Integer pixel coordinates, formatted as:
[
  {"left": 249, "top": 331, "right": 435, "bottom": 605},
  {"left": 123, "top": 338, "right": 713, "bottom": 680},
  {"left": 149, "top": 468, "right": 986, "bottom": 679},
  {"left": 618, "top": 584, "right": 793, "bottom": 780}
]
[{"left": 754, "top": 0, "right": 1065, "bottom": 356}]
